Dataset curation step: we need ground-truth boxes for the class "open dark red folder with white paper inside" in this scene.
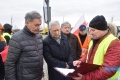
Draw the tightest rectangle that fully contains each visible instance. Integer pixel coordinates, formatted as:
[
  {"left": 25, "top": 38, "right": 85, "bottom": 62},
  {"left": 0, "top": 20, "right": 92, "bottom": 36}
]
[{"left": 55, "top": 62, "right": 100, "bottom": 78}]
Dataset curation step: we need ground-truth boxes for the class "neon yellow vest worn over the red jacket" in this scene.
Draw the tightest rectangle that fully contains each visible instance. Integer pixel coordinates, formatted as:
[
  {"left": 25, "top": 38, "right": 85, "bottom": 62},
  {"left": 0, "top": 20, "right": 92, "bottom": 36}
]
[{"left": 86, "top": 34, "right": 120, "bottom": 80}]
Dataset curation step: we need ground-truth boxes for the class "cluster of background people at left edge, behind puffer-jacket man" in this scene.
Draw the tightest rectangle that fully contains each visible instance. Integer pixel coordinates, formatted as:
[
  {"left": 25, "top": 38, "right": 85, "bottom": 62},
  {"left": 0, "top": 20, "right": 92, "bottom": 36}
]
[{"left": 0, "top": 24, "right": 12, "bottom": 80}]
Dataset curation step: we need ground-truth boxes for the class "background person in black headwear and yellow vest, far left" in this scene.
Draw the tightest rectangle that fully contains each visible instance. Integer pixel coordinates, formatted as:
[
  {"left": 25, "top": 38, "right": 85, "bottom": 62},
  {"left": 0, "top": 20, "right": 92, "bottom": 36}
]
[{"left": 3, "top": 24, "right": 12, "bottom": 45}]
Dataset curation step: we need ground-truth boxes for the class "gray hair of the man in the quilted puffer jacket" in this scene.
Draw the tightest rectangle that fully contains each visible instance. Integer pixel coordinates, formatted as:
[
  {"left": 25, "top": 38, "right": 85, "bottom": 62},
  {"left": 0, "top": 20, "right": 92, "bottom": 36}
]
[{"left": 25, "top": 11, "right": 41, "bottom": 22}]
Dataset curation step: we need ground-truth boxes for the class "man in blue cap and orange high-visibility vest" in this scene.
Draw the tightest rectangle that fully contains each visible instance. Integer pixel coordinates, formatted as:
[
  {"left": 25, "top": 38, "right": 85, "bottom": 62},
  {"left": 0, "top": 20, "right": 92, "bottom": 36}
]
[{"left": 76, "top": 25, "right": 91, "bottom": 57}]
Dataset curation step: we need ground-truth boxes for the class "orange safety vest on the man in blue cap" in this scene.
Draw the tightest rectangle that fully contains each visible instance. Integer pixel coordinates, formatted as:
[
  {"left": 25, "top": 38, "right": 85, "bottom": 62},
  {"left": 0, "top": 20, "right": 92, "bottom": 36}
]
[{"left": 76, "top": 34, "right": 91, "bottom": 57}]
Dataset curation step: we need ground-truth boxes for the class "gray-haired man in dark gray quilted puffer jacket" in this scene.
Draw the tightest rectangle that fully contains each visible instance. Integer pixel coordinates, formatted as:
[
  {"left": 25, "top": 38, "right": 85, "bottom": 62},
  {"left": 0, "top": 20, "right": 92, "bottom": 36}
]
[{"left": 5, "top": 11, "right": 43, "bottom": 80}]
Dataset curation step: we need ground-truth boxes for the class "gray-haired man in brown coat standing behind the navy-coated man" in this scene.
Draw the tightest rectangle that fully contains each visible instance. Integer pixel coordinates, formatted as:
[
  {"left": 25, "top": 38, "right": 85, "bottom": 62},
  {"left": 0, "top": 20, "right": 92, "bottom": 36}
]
[{"left": 61, "top": 22, "right": 82, "bottom": 60}]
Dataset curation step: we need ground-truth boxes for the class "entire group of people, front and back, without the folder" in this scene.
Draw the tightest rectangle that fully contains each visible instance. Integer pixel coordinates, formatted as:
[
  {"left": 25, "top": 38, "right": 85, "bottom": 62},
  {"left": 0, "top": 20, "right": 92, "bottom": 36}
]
[{"left": 0, "top": 11, "right": 120, "bottom": 80}]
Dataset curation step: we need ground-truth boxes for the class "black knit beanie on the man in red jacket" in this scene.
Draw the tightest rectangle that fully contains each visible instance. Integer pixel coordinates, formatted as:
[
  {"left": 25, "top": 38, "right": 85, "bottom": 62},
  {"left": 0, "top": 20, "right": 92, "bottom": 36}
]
[{"left": 89, "top": 15, "right": 108, "bottom": 30}]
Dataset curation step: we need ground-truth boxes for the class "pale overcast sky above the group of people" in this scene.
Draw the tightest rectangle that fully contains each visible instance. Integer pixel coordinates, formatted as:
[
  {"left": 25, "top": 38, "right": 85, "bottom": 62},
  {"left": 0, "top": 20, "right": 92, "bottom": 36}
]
[{"left": 0, "top": 0, "right": 120, "bottom": 28}]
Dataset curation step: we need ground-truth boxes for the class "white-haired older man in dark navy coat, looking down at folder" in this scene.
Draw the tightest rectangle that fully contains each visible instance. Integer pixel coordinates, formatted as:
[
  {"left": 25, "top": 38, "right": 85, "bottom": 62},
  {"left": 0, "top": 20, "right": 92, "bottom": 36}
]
[{"left": 43, "top": 21, "right": 73, "bottom": 80}]
